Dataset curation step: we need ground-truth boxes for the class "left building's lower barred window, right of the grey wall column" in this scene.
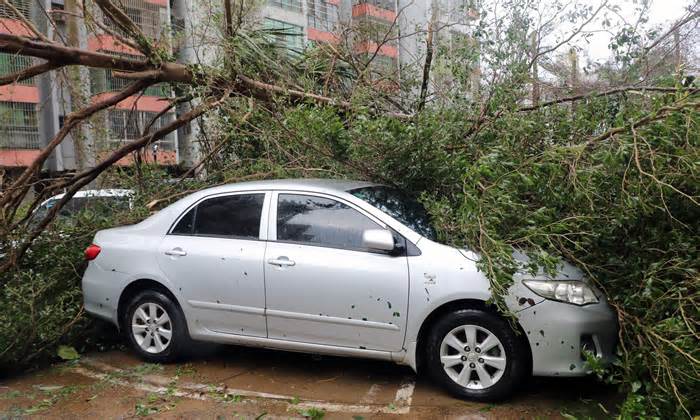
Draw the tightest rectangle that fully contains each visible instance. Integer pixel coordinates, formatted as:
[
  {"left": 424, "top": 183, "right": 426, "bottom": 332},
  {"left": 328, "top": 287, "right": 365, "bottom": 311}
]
[{"left": 108, "top": 109, "right": 175, "bottom": 150}]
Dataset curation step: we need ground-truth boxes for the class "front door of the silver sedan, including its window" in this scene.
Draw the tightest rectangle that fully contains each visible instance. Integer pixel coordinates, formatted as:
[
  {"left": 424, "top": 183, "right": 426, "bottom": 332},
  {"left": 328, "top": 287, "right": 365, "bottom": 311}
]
[{"left": 265, "top": 192, "right": 408, "bottom": 351}]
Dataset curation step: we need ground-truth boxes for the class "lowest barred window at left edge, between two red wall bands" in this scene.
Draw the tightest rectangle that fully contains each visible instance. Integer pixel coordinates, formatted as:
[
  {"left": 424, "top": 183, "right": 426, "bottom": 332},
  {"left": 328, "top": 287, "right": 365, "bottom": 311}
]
[{"left": 0, "top": 102, "right": 40, "bottom": 149}]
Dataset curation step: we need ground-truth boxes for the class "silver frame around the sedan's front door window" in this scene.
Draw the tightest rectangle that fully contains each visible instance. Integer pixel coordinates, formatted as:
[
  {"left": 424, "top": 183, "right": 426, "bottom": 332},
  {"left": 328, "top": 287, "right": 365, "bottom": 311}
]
[{"left": 267, "top": 190, "right": 400, "bottom": 253}]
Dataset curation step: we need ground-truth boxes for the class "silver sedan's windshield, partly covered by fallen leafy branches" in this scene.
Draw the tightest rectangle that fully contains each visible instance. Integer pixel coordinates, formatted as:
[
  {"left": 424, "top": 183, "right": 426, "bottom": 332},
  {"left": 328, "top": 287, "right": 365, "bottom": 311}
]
[{"left": 348, "top": 186, "right": 437, "bottom": 241}]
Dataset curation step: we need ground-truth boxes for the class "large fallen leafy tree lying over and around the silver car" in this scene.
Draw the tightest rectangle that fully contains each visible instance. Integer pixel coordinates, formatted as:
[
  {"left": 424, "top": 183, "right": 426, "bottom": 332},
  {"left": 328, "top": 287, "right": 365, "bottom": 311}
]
[{"left": 0, "top": 0, "right": 700, "bottom": 416}]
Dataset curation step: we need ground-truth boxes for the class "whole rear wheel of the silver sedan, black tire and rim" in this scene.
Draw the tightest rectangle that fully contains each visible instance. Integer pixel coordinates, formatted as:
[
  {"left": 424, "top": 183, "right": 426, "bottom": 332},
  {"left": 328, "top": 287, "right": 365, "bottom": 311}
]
[{"left": 122, "top": 290, "right": 190, "bottom": 363}]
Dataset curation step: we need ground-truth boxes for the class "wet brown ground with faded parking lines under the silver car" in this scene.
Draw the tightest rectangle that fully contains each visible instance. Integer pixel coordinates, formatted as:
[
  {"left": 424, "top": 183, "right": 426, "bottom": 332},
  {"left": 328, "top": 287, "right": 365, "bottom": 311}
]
[{"left": 0, "top": 346, "right": 618, "bottom": 419}]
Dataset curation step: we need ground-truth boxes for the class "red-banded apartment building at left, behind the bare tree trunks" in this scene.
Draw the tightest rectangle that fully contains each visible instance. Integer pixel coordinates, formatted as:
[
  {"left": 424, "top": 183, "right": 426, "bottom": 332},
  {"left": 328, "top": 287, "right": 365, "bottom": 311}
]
[{"left": 0, "top": 0, "right": 178, "bottom": 173}]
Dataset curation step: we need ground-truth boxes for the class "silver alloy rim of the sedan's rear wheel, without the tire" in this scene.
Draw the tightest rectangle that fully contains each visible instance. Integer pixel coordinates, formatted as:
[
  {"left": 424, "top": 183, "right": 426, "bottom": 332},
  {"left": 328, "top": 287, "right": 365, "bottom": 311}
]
[{"left": 131, "top": 302, "right": 173, "bottom": 354}]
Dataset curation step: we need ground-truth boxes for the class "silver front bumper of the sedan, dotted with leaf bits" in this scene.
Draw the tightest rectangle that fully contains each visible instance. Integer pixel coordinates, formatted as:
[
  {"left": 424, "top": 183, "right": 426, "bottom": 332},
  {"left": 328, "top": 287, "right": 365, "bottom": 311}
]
[{"left": 517, "top": 300, "right": 617, "bottom": 376}]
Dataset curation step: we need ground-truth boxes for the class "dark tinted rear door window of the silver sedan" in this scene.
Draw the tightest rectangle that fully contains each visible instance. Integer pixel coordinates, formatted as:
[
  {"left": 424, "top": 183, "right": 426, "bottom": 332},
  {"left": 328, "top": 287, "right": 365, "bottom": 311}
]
[{"left": 172, "top": 194, "right": 265, "bottom": 239}]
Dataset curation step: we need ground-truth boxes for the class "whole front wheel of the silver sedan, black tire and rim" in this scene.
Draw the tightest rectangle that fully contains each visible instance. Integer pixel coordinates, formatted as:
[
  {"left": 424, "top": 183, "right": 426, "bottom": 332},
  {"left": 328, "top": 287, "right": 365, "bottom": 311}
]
[{"left": 425, "top": 309, "right": 528, "bottom": 402}]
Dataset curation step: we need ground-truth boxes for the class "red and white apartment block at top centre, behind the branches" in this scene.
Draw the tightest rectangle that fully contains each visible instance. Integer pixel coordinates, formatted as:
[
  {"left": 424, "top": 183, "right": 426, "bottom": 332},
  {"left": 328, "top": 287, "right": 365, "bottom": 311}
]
[{"left": 262, "top": 0, "right": 478, "bottom": 85}]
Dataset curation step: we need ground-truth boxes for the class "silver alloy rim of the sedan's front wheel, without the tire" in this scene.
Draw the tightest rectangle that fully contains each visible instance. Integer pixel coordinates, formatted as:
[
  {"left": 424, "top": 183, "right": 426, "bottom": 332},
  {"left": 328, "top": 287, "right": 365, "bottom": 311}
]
[{"left": 440, "top": 325, "right": 507, "bottom": 389}]
